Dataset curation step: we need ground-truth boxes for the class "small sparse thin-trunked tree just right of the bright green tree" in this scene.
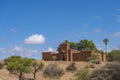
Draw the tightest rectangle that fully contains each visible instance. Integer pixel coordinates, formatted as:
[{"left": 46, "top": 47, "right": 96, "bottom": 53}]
[{"left": 32, "top": 61, "right": 44, "bottom": 80}]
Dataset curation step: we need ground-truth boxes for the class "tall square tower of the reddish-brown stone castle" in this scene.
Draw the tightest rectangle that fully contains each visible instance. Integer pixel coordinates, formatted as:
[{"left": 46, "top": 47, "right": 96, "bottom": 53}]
[{"left": 58, "top": 42, "right": 70, "bottom": 61}]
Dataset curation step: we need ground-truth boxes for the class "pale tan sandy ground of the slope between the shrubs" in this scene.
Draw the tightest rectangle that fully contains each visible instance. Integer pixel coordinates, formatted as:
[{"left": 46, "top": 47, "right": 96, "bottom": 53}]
[{"left": 0, "top": 61, "right": 105, "bottom": 80}]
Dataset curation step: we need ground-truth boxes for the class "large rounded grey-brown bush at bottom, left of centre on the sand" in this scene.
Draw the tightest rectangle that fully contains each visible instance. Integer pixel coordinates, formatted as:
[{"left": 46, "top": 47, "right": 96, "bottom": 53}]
[{"left": 43, "top": 64, "right": 64, "bottom": 80}]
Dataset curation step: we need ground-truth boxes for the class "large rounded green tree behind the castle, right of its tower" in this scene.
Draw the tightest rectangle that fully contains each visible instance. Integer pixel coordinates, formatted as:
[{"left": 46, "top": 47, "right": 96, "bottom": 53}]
[{"left": 78, "top": 39, "right": 97, "bottom": 50}]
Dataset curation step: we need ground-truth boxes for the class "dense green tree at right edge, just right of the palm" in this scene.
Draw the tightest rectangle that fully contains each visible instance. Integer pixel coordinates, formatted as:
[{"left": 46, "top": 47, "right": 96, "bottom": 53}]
[{"left": 107, "top": 50, "right": 120, "bottom": 61}]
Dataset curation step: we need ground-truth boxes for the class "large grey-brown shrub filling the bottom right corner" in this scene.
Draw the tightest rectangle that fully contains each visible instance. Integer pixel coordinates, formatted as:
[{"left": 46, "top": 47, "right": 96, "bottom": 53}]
[{"left": 91, "top": 62, "right": 120, "bottom": 80}]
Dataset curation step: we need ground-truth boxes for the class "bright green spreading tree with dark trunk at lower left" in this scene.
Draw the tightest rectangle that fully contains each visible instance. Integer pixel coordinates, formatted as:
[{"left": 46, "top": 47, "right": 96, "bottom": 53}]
[{"left": 7, "top": 56, "right": 32, "bottom": 80}]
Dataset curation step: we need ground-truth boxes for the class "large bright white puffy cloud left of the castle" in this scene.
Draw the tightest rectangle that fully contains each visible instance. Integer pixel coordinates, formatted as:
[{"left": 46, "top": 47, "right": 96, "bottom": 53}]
[{"left": 24, "top": 34, "right": 45, "bottom": 44}]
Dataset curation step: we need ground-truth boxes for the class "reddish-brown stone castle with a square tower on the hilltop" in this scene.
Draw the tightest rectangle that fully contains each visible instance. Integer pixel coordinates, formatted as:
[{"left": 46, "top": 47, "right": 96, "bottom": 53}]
[{"left": 42, "top": 42, "right": 105, "bottom": 61}]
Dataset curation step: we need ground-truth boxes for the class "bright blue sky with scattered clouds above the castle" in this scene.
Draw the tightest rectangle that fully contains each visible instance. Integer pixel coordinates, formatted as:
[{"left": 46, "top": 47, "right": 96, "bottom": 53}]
[{"left": 0, "top": 0, "right": 120, "bottom": 59}]
